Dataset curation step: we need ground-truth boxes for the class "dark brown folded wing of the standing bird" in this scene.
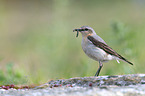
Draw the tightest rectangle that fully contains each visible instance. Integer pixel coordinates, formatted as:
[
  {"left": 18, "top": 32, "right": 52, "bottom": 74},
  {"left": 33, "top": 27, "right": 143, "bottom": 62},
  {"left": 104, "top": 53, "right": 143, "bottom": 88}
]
[{"left": 87, "top": 36, "right": 133, "bottom": 65}]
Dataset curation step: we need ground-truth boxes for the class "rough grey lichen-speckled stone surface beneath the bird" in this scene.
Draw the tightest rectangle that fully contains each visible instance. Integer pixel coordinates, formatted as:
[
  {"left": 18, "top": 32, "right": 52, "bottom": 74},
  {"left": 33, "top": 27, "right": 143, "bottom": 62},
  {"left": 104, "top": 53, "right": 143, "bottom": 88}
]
[{"left": 0, "top": 74, "right": 145, "bottom": 96}]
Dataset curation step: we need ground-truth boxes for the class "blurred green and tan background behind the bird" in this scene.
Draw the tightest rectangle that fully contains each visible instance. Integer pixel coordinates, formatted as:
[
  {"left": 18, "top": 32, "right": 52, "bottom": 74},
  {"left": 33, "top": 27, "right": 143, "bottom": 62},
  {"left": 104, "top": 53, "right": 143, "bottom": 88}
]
[{"left": 0, "top": 0, "right": 145, "bottom": 84}]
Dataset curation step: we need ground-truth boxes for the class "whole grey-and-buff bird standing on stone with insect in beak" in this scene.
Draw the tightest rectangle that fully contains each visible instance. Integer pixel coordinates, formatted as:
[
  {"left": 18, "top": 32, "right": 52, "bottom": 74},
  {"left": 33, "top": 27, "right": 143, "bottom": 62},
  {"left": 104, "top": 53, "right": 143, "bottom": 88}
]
[{"left": 73, "top": 26, "right": 133, "bottom": 76}]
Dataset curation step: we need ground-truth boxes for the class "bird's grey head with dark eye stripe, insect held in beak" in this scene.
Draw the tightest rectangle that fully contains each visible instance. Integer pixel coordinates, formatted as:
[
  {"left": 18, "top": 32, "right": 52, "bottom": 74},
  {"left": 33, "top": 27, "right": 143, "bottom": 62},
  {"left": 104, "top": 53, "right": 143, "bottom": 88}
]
[{"left": 73, "top": 26, "right": 96, "bottom": 37}]
